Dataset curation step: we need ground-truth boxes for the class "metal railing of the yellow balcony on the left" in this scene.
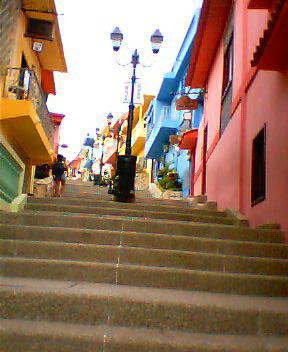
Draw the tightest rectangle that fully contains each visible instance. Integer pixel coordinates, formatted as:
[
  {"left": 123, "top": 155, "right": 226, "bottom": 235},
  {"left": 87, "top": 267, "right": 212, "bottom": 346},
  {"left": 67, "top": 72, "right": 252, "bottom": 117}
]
[{"left": 4, "top": 67, "right": 56, "bottom": 149}]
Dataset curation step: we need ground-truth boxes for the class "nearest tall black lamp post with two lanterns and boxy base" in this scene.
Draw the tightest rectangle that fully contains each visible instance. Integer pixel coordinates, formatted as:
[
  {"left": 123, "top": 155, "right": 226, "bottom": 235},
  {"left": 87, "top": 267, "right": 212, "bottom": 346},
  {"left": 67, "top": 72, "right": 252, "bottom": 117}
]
[{"left": 110, "top": 27, "right": 163, "bottom": 202}]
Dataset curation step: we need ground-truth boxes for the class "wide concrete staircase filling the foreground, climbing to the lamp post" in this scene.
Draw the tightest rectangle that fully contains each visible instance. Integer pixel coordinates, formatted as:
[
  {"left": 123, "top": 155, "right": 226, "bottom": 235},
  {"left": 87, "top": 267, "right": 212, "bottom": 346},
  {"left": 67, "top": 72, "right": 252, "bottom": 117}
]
[{"left": 0, "top": 183, "right": 288, "bottom": 352}]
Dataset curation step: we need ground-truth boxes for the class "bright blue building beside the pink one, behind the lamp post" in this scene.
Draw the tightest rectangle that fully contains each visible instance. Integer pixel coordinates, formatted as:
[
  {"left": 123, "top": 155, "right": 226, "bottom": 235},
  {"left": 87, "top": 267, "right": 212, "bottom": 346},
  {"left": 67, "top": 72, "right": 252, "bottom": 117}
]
[{"left": 144, "top": 10, "right": 203, "bottom": 197}]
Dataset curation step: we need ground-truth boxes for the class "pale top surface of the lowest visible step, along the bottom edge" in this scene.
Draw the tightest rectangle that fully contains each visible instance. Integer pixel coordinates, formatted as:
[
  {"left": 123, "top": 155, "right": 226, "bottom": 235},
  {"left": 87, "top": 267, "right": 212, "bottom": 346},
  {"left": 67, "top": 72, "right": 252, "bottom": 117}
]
[{"left": 0, "top": 318, "right": 288, "bottom": 351}]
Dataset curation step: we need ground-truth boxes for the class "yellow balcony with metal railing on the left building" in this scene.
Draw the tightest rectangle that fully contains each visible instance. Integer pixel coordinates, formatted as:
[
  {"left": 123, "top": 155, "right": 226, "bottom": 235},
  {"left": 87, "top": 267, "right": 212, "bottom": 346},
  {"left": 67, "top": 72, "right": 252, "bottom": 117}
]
[{"left": 0, "top": 68, "right": 56, "bottom": 165}]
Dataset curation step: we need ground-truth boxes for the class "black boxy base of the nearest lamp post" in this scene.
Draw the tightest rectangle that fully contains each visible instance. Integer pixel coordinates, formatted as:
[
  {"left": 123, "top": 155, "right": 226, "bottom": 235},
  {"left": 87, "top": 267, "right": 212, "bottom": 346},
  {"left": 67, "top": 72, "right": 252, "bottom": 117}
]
[{"left": 109, "top": 155, "right": 137, "bottom": 203}]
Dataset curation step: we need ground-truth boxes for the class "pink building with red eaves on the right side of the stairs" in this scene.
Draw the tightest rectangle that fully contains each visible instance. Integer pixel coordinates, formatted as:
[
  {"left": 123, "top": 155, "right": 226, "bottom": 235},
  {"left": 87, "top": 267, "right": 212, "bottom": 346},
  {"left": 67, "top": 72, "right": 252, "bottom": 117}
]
[{"left": 186, "top": 0, "right": 288, "bottom": 241}]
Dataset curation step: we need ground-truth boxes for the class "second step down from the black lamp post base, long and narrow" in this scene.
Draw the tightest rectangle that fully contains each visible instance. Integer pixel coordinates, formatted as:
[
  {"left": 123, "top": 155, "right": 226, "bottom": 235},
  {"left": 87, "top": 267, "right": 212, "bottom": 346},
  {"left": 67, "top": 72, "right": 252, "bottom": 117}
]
[{"left": 25, "top": 203, "right": 234, "bottom": 225}]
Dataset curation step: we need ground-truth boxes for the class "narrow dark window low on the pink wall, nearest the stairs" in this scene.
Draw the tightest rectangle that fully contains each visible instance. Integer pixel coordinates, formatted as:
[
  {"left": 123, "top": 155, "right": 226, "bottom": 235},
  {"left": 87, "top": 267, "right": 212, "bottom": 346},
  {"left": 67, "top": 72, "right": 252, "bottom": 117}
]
[{"left": 251, "top": 125, "right": 266, "bottom": 206}]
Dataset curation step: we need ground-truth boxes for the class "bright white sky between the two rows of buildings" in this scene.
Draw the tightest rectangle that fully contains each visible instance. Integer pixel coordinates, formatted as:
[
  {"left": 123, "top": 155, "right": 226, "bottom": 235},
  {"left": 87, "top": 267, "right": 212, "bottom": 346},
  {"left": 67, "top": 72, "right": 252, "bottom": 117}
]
[{"left": 48, "top": 0, "right": 202, "bottom": 160}]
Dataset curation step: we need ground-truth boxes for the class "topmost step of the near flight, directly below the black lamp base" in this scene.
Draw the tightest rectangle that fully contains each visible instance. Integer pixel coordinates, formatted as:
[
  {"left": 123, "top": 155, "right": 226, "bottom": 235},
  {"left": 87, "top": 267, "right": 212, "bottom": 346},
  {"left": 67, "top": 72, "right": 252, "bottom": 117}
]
[{"left": 28, "top": 197, "right": 227, "bottom": 217}]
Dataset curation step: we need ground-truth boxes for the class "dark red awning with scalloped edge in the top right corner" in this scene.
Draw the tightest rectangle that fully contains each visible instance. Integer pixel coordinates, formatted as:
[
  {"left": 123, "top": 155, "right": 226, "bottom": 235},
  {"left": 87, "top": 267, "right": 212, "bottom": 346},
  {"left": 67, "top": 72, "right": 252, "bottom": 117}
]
[{"left": 251, "top": 0, "right": 288, "bottom": 71}]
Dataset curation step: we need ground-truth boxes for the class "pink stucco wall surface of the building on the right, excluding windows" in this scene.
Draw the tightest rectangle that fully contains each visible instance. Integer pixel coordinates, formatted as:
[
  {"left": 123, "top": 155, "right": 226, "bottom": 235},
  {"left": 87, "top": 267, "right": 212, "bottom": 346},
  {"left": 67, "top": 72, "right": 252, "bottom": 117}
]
[{"left": 194, "top": 0, "right": 288, "bottom": 242}]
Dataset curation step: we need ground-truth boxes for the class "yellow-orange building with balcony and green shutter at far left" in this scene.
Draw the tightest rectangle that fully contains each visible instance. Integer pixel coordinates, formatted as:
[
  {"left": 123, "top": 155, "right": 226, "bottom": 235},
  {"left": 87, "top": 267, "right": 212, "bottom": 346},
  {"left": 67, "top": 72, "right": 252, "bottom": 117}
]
[{"left": 0, "top": 0, "right": 67, "bottom": 211}]
